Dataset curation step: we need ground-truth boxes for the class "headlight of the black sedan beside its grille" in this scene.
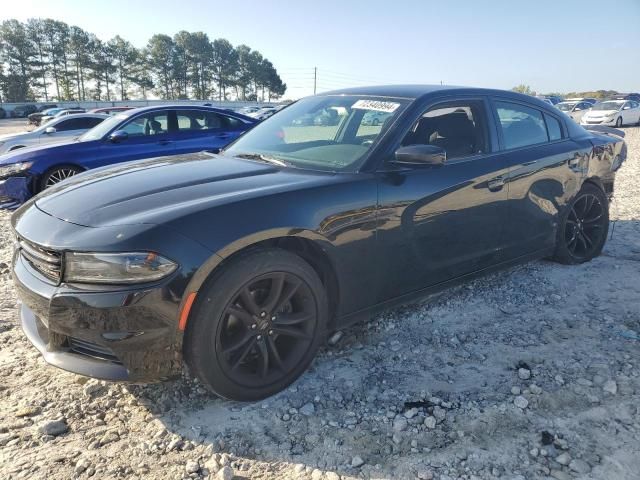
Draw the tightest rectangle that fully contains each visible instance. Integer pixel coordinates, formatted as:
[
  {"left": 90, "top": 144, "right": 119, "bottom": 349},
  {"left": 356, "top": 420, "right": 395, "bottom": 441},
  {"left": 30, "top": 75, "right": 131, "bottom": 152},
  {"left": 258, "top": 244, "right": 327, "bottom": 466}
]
[{"left": 64, "top": 252, "right": 178, "bottom": 284}]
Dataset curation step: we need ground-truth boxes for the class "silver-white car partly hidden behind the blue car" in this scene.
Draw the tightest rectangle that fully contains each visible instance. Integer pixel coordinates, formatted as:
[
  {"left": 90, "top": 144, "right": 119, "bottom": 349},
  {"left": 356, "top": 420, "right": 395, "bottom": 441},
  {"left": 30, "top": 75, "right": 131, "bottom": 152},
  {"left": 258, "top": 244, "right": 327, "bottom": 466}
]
[{"left": 0, "top": 113, "right": 109, "bottom": 154}]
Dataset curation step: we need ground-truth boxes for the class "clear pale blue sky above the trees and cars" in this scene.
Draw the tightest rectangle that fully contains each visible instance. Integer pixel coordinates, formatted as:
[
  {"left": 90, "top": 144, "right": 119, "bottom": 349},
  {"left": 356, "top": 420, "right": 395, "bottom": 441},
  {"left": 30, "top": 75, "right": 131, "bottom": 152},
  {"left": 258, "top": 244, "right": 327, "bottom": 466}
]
[{"left": 0, "top": 0, "right": 640, "bottom": 98}]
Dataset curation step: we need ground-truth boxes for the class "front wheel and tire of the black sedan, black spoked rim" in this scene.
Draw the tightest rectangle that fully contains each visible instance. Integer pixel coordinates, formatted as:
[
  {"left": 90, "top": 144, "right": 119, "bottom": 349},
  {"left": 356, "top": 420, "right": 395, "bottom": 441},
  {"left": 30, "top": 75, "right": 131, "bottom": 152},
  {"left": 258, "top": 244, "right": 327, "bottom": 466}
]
[{"left": 184, "top": 249, "right": 328, "bottom": 401}]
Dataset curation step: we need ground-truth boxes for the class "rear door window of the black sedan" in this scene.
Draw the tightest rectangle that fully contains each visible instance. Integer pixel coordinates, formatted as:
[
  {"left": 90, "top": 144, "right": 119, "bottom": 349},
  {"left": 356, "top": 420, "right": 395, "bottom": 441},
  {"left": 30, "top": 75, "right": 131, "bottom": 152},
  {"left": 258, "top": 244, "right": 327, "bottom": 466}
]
[{"left": 496, "top": 102, "right": 549, "bottom": 150}]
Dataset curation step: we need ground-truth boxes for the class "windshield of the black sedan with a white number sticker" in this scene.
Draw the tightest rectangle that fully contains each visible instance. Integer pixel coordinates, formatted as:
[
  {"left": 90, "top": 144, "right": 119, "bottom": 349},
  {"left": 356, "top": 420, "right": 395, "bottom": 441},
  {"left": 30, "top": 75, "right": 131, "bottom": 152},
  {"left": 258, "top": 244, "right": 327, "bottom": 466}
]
[{"left": 224, "top": 95, "right": 408, "bottom": 171}]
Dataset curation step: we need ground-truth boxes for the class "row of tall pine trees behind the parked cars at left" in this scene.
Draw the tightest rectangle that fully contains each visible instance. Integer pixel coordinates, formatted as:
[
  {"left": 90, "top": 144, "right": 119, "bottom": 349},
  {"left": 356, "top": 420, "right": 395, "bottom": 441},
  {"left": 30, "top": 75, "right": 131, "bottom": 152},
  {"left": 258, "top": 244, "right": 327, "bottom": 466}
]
[{"left": 0, "top": 18, "right": 287, "bottom": 102}]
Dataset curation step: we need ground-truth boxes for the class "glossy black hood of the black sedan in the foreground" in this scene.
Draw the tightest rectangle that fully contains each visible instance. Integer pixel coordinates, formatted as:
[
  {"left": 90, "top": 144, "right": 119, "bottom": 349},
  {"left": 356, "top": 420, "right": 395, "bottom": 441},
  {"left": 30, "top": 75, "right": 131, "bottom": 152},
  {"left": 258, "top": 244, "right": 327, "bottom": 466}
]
[{"left": 35, "top": 152, "right": 333, "bottom": 227}]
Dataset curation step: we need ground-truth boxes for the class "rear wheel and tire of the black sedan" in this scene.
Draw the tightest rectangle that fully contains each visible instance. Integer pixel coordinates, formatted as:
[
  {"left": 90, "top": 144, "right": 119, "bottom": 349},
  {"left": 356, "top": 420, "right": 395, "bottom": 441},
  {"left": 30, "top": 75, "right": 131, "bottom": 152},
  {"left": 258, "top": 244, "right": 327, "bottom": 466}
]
[{"left": 553, "top": 183, "right": 609, "bottom": 265}]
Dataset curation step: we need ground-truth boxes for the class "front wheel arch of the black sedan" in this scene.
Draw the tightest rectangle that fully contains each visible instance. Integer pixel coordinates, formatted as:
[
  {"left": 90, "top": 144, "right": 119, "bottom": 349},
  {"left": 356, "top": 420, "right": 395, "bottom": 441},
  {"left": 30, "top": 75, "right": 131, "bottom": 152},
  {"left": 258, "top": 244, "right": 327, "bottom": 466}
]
[{"left": 180, "top": 229, "right": 340, "bottom": 330}]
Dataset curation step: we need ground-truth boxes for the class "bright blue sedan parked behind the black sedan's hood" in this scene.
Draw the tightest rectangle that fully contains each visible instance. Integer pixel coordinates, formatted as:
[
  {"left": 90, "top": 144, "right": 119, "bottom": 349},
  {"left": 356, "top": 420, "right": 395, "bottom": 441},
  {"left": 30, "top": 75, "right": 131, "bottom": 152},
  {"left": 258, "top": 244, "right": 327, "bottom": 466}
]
[{"left": 0, "top": 105, "right": 257, "bottom": 207}]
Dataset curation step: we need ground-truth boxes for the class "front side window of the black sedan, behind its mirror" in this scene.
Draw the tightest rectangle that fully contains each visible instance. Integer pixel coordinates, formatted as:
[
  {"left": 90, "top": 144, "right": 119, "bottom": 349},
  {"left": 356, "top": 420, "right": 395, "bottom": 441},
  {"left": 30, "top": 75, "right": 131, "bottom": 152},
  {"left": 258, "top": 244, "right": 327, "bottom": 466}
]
[{"left": 402, "top": 101, "right": 488, "bottom": 160}]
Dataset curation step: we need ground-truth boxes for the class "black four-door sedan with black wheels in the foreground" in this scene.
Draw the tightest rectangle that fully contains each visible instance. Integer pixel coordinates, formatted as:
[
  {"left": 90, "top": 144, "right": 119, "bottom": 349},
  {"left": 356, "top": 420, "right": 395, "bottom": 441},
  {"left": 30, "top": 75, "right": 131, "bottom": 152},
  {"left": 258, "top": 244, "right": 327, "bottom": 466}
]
[{"left": 12, "top": 86, "right": 626, "bottom": 400}]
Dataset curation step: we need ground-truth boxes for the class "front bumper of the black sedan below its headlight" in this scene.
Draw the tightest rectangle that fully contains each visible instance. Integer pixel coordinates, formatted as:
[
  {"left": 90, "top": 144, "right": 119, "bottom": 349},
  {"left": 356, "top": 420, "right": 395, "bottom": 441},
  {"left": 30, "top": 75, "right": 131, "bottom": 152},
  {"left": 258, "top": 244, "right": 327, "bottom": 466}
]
[{"left": 13, "top": 251, "right": 182, "bottom": 382}]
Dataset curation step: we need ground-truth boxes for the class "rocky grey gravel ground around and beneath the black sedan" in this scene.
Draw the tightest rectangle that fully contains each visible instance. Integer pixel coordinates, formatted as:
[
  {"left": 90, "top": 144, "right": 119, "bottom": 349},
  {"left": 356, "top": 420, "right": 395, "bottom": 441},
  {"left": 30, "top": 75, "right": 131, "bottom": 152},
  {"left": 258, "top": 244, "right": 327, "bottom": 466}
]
[{"left": 0, "top": 124, "right": 640, "bottom": 480}]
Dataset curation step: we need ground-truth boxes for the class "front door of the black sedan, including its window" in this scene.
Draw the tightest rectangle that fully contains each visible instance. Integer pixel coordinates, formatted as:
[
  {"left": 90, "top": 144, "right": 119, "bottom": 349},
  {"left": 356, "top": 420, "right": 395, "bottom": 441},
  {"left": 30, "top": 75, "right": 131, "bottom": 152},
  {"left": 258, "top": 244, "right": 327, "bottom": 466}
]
[{"left": 378, "top": 98, "right": 507, "bottom": 301}]
